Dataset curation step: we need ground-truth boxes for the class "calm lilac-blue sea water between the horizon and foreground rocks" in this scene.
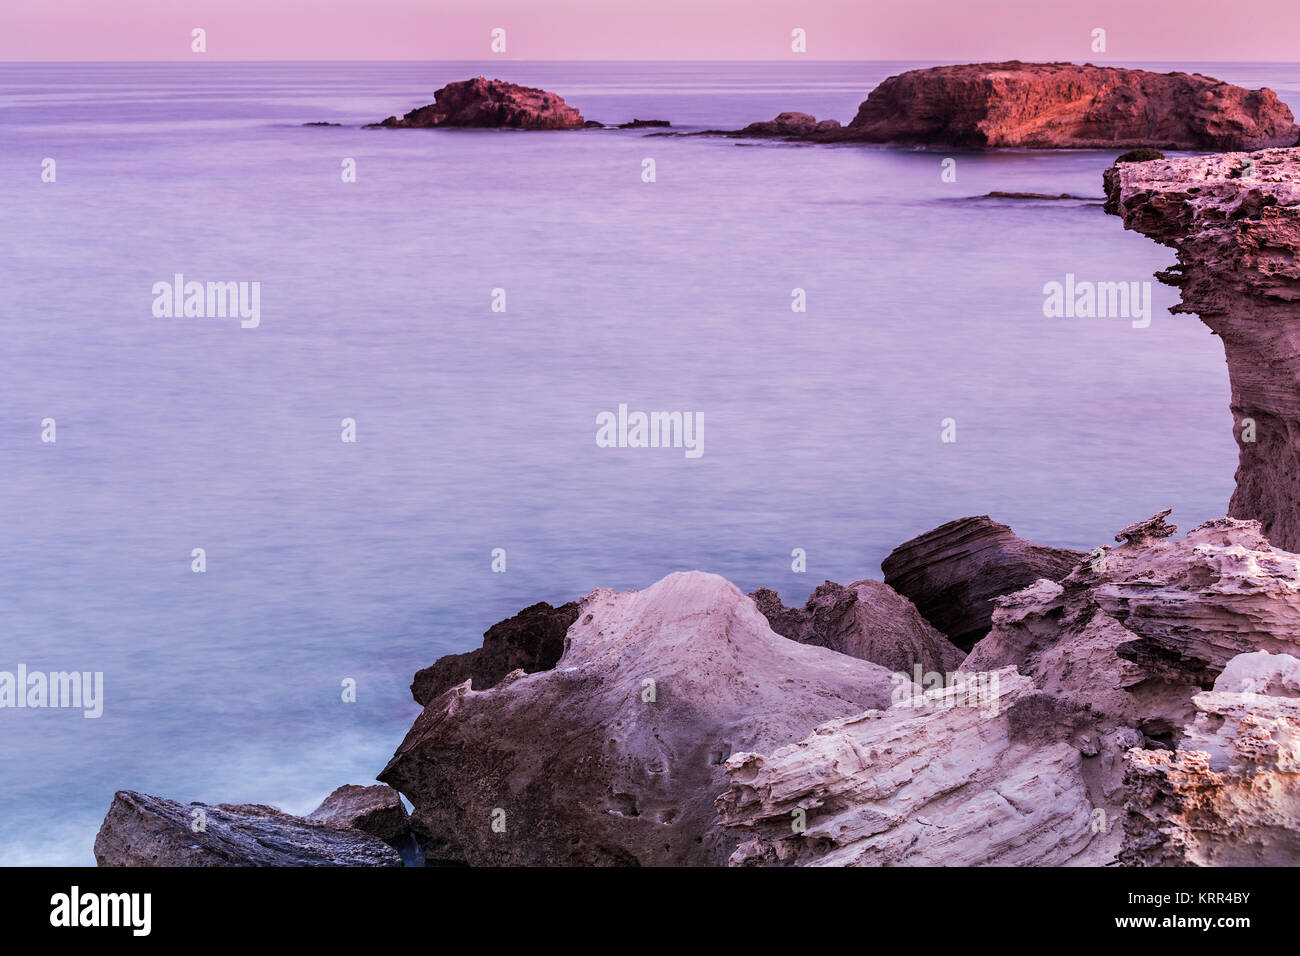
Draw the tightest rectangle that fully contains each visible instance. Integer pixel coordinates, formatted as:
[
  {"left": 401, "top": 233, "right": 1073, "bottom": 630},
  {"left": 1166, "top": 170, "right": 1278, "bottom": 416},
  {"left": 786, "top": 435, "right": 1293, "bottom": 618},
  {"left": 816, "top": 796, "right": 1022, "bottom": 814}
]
[{"left": 0, "top": 61, "right": 1300, "bottom": 864}]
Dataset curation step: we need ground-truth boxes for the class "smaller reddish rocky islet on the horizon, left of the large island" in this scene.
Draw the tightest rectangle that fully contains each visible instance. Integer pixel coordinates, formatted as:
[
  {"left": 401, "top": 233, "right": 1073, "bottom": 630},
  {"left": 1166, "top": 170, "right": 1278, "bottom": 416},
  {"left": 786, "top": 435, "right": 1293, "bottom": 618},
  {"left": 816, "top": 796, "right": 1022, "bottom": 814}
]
[{"left": 374, "top": 77, "right": 582, "bottom": 130}]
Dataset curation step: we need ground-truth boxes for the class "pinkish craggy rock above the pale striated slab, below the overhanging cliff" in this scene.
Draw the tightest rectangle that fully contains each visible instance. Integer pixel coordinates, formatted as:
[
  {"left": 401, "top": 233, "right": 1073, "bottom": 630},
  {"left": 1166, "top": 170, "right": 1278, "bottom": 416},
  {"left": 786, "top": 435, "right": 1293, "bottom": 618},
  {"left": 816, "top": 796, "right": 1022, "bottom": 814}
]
[{"left": 962, "top": 512, "right": 1300, "bottom": 747}]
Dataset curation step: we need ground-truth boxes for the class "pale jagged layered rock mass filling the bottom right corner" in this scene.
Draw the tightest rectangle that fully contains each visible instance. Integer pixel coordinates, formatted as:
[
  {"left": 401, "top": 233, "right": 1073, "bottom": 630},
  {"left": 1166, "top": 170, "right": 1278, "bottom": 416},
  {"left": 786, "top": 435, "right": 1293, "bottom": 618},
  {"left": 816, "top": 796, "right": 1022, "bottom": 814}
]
[{"left": 718, "top": 512, "right": 1300, "bottom": 865}]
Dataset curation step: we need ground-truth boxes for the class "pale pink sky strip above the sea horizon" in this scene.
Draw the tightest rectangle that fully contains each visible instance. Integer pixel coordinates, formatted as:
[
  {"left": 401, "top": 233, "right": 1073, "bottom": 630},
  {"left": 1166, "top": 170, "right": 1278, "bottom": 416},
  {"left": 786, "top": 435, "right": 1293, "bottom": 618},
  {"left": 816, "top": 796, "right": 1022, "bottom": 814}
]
[{"left": 0, "top": 0, "right": 1300, "bottom": 62}]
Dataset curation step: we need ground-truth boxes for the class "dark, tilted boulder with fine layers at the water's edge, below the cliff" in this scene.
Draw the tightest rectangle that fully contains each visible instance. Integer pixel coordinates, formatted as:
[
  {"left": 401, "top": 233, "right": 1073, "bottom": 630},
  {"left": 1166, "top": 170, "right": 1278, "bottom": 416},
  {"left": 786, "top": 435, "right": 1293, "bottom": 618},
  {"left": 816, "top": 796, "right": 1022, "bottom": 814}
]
[{"left": 880, "top": 515, "right": 1083, "bottom": 650}]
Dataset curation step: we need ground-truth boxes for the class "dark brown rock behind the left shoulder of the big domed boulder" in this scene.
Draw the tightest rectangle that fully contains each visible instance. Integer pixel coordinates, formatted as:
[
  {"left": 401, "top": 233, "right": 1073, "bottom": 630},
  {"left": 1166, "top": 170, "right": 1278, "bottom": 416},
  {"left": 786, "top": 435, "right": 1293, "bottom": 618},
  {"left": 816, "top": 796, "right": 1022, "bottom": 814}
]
[{"left": 411, "top": 601, "right": 577, "bottom": 706}]
